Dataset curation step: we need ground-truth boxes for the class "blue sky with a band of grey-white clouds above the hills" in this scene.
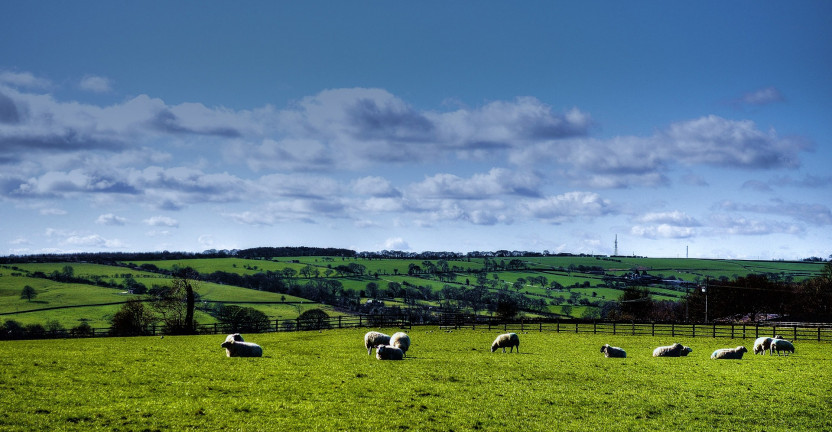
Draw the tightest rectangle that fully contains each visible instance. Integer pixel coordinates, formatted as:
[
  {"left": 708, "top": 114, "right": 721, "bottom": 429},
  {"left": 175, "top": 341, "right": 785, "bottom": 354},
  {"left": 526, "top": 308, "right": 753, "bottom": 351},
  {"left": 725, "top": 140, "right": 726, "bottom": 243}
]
[{"left": 0, "top": 1, "right": 832, "bottom": 260}]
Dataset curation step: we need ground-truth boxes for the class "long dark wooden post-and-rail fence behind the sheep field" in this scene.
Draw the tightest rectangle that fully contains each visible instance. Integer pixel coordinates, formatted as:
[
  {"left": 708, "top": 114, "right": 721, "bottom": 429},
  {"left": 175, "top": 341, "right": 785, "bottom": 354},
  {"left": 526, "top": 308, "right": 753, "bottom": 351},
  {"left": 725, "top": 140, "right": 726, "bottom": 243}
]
[{"left": 0, "top": 314, "right": 832, "bottom": 342}]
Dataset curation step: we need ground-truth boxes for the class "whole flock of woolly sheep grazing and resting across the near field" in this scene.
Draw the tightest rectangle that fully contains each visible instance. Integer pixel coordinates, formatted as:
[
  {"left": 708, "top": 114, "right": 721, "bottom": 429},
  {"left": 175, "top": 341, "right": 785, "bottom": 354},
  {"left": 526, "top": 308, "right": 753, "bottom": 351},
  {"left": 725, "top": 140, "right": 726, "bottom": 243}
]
[{"left": 220, "top": 331, "right": 794, "bottom": 360}]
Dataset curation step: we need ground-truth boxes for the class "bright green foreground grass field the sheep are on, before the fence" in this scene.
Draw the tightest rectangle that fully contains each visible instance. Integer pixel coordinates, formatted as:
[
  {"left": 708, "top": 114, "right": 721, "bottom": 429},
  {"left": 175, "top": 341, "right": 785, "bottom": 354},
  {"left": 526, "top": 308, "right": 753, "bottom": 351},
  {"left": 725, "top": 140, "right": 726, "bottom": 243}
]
[{"left": 0, "top": 327, "right": 832, "bottom": 431}]
